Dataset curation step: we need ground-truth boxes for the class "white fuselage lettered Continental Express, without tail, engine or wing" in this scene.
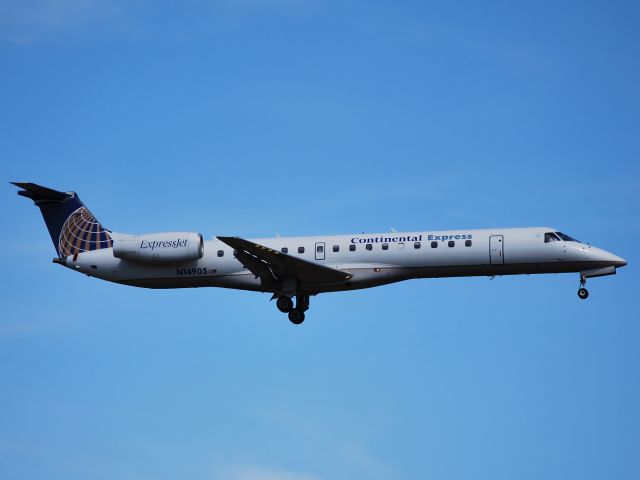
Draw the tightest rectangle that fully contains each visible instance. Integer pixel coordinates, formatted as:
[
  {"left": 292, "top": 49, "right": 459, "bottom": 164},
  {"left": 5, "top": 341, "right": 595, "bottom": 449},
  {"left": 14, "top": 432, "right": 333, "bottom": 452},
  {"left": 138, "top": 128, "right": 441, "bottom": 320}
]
[{"left": 65, "top": 227, "right": 626, "bottom": 294}]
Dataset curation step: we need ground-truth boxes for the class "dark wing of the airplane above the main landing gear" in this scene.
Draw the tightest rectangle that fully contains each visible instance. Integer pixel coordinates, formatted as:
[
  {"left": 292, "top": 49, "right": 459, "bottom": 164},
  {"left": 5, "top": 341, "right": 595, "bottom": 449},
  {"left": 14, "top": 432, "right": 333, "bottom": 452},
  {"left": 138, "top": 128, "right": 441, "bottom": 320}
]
[{"left": 218, "top": 237, "right": 352, "bottom": 284}]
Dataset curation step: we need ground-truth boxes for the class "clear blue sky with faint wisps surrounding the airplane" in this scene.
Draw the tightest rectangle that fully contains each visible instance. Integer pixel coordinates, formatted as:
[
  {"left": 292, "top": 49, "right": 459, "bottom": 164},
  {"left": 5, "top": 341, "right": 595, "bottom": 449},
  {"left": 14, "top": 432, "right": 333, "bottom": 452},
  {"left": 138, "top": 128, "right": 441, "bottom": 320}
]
[{"left": 0, "top": 0, "right": 640, "bottom": 480}]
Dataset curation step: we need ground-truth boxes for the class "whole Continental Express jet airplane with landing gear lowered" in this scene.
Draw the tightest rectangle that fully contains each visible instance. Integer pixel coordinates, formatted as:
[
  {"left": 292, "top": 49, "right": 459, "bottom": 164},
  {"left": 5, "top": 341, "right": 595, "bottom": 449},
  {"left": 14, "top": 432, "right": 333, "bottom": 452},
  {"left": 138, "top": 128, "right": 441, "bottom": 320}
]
[{"left": 11, "top": 182, "right": 627, "bottom": 325}]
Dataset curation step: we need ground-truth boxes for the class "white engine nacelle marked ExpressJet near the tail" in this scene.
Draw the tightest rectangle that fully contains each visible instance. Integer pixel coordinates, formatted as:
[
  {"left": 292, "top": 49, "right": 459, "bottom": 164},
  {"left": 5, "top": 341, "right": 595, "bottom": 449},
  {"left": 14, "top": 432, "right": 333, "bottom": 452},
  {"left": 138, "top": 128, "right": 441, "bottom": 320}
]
[{"left": 113, "top": 232, "right": 204, "bottom": 264}]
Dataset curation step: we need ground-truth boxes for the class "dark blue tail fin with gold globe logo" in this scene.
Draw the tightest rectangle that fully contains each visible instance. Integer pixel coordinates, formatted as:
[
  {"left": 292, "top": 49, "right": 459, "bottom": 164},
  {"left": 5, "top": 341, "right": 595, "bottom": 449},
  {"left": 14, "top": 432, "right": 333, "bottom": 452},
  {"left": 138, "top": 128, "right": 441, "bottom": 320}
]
[{"left": 11, "top": 182, "right": 113, "bottom": 258}]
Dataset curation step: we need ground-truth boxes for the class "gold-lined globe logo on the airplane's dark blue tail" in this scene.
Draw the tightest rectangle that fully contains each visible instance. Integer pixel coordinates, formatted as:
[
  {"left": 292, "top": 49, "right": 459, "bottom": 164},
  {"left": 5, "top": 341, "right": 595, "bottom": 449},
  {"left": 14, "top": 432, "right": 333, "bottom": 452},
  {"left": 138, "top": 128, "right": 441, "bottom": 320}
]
[{"left": 58, "top": 206, "right": 113, "bottom": 257}]
